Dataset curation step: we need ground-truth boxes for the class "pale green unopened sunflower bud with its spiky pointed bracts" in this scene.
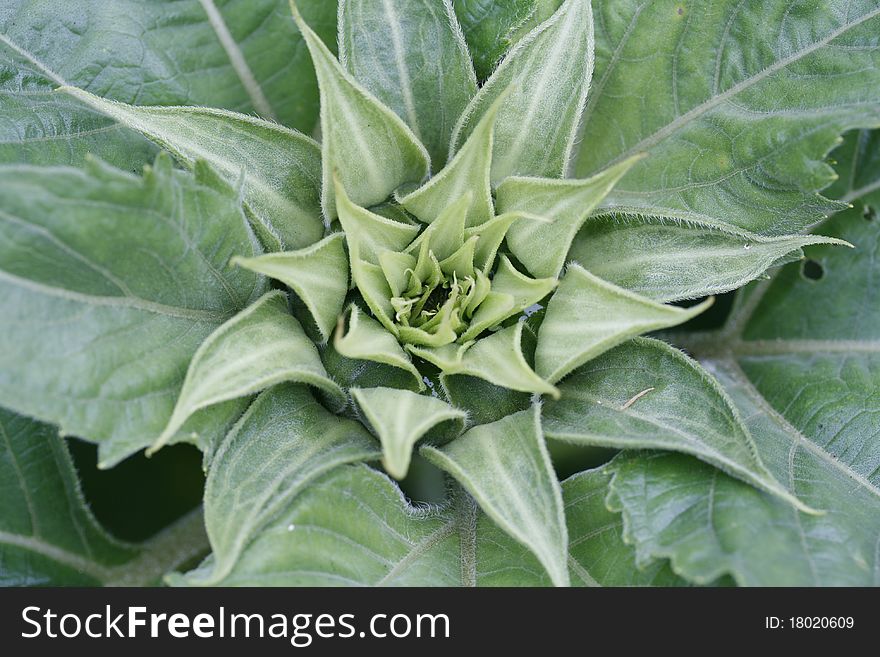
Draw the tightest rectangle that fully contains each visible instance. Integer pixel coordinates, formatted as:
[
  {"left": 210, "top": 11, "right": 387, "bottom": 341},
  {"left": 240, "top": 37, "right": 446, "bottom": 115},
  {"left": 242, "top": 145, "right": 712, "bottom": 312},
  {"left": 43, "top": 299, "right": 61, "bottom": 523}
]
[{"left": 49, "top": 0, "right": 832, "bottom": 584}]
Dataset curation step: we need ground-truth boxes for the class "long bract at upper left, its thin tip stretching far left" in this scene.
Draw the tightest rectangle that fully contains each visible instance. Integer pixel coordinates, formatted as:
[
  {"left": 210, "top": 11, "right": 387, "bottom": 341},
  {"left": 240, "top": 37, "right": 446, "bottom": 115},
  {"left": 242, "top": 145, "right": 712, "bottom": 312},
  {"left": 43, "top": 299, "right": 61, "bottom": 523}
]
[{"left": 61, "top": 92, "right": 324, "bottom": 254}]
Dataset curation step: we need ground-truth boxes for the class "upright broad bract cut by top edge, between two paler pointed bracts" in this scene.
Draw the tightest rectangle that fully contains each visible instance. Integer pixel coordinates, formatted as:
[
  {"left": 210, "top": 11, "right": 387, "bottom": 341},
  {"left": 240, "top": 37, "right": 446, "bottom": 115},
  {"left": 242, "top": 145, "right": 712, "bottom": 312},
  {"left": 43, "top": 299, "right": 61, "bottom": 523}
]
[{"left": 339, "top": 0, "right": 477, "bottom": 171}]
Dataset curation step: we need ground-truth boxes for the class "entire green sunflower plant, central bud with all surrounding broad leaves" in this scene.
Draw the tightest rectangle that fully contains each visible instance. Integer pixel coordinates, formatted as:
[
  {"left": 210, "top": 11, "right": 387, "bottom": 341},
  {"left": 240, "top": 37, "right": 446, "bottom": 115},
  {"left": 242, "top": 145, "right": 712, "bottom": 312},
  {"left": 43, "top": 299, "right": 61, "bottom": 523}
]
[{"left": 0, "top": 0, "right": 880, "bottom": 586}]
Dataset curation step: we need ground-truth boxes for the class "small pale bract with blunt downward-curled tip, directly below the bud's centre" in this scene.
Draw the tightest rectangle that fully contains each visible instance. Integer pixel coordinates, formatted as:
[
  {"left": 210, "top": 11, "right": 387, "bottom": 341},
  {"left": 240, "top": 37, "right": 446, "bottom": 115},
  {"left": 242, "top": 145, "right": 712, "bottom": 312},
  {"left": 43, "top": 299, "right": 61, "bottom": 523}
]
[{"left": 351, "top": 387, "right": 467, "bottom": 479}]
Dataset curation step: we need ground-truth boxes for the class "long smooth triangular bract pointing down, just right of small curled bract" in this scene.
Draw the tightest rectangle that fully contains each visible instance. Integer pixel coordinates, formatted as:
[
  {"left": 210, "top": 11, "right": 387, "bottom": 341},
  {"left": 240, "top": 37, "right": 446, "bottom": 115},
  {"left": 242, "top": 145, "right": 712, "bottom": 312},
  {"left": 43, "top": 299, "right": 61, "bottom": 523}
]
[{"left": 421, "top": 406, "right": 569, "bottom": 586}]
